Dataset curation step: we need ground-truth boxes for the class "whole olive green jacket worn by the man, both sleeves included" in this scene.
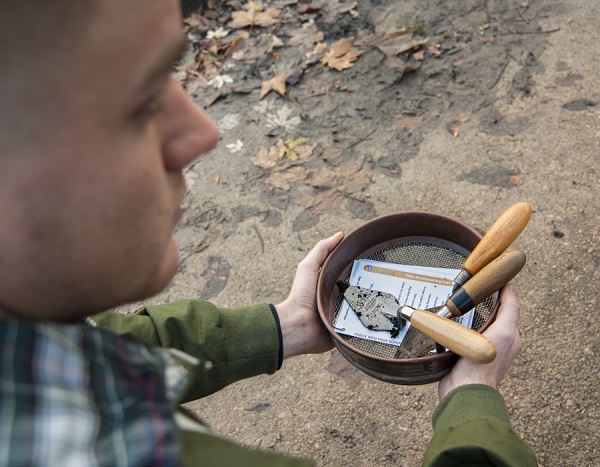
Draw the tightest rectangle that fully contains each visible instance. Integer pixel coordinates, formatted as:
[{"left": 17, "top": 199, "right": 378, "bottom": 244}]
[{"left": 93, "top": 300, "right": 537, "bottom": 467}]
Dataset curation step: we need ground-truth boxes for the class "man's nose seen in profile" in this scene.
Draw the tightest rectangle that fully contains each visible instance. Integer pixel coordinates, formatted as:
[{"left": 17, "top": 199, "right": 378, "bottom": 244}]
[{"left": 160, "top": 78, "right": 219, "bottom": 170}]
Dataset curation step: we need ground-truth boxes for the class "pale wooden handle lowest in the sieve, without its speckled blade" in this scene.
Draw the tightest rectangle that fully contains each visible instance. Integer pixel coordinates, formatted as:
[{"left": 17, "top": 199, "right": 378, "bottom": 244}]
[{"left": 410, "top": 310, "right": 496, "bottom": 363}]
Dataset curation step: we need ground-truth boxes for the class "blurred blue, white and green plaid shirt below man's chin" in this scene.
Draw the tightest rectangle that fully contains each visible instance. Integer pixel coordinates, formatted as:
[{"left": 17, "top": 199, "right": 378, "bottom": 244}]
[{"left": 0, "top": 319, "right": 196, "bottom": 467}]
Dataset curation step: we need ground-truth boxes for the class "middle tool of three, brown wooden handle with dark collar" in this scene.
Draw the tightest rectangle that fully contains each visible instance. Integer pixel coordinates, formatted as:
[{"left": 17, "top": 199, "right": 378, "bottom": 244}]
[{"left": 396, "top": 250, "right": 527, "bottom": 358}]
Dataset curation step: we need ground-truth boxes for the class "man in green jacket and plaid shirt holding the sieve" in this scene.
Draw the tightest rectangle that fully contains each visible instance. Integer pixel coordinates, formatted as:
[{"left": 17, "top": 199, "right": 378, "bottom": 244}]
[{"left": 0, "top": 0, "right": 535, "bottom": 466}]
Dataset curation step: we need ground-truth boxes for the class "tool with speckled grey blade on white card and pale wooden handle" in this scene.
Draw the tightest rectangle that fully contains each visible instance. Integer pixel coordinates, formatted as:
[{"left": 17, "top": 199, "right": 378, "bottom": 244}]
[{"left": 344, "top": 285, "right": 496, "bottom": 363}]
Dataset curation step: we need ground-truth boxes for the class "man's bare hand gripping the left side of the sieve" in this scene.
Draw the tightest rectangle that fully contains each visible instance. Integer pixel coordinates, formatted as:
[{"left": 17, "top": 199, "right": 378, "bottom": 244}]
[{"left": 275, "top": 232, "right": 344, "bottom": 358}]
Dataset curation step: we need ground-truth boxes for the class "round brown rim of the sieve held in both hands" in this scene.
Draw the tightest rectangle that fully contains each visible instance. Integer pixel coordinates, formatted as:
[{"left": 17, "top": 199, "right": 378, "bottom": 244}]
[{"left": 317, "top": 211, "right": 499, "bottom": 384}]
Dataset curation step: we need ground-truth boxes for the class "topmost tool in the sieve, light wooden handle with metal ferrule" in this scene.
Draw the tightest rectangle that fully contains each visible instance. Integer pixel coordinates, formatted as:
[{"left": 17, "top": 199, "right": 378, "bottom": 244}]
[{"left": 452, "top": 201, "right": 531, "bottom": 291}]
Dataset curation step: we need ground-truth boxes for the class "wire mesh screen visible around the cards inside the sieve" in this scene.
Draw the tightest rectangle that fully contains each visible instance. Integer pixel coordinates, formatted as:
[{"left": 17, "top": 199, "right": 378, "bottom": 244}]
[{"left": 335, "top": 242, "right": 497, "bottom": 358}]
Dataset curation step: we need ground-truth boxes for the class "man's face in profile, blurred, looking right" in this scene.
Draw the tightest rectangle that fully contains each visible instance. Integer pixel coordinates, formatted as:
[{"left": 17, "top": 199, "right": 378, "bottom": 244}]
[{"left": 0, "top": 0, "right": 218, "bottom": 320}]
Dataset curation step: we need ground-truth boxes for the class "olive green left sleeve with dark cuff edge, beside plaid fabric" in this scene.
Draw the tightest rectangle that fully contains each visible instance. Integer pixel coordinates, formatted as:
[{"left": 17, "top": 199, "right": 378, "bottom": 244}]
[{"left": 92, "top": 300, "right": 282, "bottom": 402}]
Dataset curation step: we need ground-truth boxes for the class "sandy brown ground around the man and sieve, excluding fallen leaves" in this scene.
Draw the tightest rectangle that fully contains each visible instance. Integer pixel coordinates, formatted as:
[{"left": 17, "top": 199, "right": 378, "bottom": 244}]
[{"left": 124, "top": 0, "right": 600, "bottom": 466}]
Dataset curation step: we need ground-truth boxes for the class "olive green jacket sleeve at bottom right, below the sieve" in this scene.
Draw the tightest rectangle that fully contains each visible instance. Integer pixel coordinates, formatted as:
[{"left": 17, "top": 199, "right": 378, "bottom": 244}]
[{"left": 423, "top": 384, "right": 538, "bottom": 467}]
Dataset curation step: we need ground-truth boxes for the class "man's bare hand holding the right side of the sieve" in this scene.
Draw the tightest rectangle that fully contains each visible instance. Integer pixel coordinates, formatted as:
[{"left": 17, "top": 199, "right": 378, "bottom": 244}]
[{"left": 438, "top": 284, "right": 522, "bottom": 400}]
